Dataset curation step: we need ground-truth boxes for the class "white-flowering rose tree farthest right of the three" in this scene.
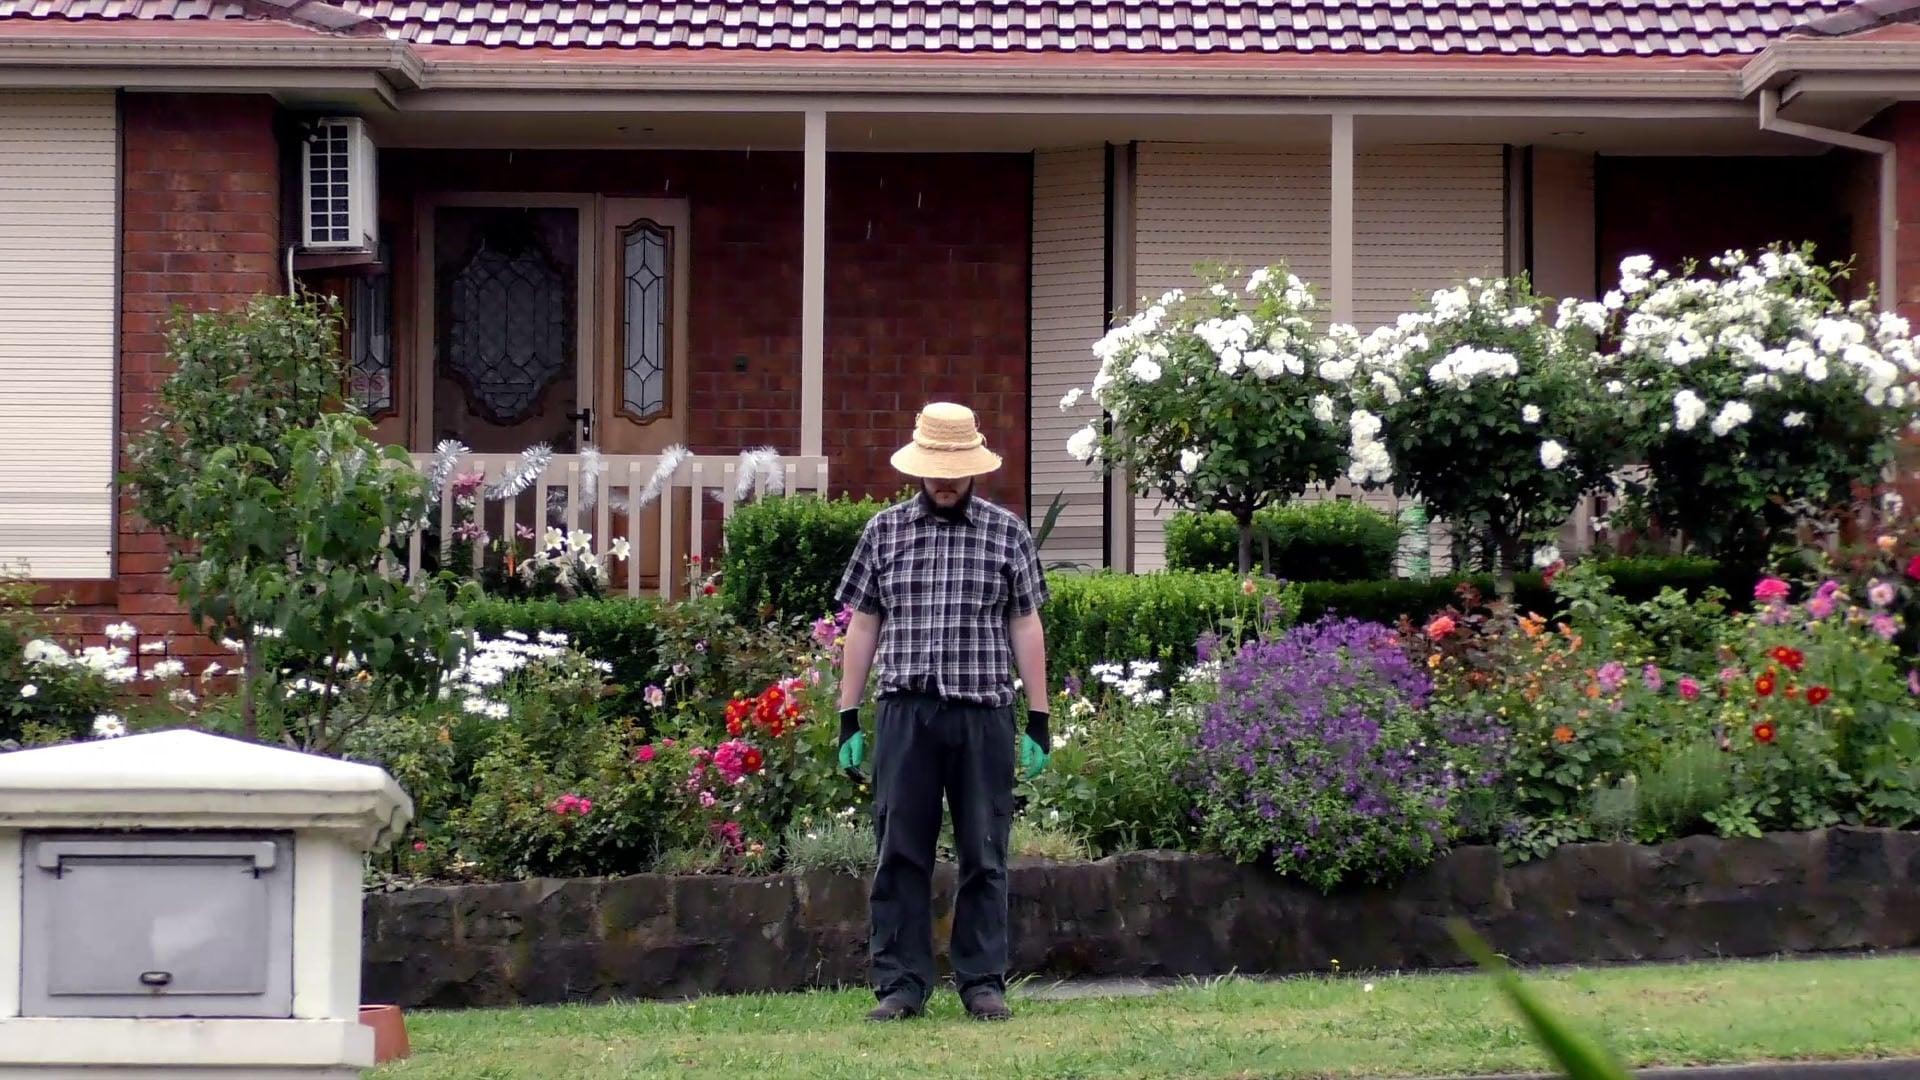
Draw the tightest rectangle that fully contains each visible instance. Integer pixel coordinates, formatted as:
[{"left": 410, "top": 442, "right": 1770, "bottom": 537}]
[{"left": 1589, "top": 246, "right": 1920, "bottom": 567}]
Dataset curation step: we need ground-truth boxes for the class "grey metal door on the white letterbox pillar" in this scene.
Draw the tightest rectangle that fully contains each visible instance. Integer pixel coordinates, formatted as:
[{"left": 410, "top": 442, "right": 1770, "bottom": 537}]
[{"left": 21, "top": 834, "right": 294, "bottom": 1017}]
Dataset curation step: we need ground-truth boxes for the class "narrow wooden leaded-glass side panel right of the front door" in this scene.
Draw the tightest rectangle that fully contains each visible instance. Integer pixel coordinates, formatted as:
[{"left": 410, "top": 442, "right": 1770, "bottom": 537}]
[{"left": 589, "top": 198, "right": 695, "bottom": 588}]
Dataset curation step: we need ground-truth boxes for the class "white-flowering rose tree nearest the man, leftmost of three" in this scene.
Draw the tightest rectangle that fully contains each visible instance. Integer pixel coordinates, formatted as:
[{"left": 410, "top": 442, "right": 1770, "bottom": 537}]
[{"left": 1060, "top": 265, "right": 1354, "bottom": 573}]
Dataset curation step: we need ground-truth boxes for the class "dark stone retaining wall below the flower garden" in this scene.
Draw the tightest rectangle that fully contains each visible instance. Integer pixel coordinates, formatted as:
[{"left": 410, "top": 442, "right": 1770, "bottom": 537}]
[{"left": 363, "top": 828, "right": 1920, "bottom": 1007}]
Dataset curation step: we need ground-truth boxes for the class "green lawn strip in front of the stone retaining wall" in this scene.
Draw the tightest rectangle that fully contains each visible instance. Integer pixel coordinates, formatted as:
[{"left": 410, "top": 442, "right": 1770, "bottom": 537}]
[{"left": 372, "top": 955, "right": 1920, "bottom": 1080}]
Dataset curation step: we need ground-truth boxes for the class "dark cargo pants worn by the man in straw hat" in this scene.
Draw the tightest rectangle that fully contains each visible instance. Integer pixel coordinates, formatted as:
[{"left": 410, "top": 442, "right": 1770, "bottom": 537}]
[{"left": 868, "top": 694, "right": 1014, "bottom": 1003}]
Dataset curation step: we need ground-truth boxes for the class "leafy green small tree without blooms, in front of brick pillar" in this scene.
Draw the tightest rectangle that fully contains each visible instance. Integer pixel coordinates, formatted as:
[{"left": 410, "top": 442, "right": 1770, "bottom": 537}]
[{"left": 125, "top": 296, "right": 472, "bottom": 749}]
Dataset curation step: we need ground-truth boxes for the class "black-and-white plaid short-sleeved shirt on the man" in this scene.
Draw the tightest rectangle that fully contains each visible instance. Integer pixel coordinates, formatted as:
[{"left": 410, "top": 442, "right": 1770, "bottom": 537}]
[{"left": 839, "top": 496, "right": 1046, "bottom": 705}]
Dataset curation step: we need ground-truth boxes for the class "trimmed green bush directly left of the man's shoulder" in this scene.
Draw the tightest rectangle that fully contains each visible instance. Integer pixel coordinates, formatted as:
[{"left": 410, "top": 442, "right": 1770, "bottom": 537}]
[{"left": 720, "top": 496, "right": 887, "bottom": 625}]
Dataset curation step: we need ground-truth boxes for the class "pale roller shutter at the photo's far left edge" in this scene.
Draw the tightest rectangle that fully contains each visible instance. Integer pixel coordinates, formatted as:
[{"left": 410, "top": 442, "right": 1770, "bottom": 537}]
[{"left": 0, "top": 92, "right": 119, "bottom": 578}]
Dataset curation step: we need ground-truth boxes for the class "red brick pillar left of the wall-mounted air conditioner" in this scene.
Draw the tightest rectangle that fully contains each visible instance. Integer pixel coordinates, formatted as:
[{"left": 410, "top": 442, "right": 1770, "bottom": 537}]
[{"left": 115, "top": 94, "right": 284, "bottom": 655}]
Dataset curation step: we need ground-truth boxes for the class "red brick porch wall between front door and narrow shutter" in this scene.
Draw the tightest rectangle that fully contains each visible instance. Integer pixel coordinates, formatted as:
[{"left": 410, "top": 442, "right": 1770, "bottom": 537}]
[{"left": 380, "top": 150, "right": 1031, "bottom": 507}]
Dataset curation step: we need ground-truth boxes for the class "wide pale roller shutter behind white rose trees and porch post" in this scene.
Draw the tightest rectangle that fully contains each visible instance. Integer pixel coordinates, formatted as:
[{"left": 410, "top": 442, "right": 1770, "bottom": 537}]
[{"left": 1135, "top": 144, "right": 1505, "bottom": 571}]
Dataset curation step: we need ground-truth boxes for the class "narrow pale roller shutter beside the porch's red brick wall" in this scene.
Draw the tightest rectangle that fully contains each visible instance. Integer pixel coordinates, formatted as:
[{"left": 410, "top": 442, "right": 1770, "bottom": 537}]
[{"left": 1029, "top": 148, "right": 1106, "bottom": 567}]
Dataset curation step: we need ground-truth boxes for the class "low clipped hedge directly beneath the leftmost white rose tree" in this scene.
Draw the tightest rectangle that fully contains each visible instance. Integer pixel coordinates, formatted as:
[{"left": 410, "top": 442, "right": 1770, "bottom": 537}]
[{"left": 1167, "top": 502, "right": 1402, "bottom": 580}]
